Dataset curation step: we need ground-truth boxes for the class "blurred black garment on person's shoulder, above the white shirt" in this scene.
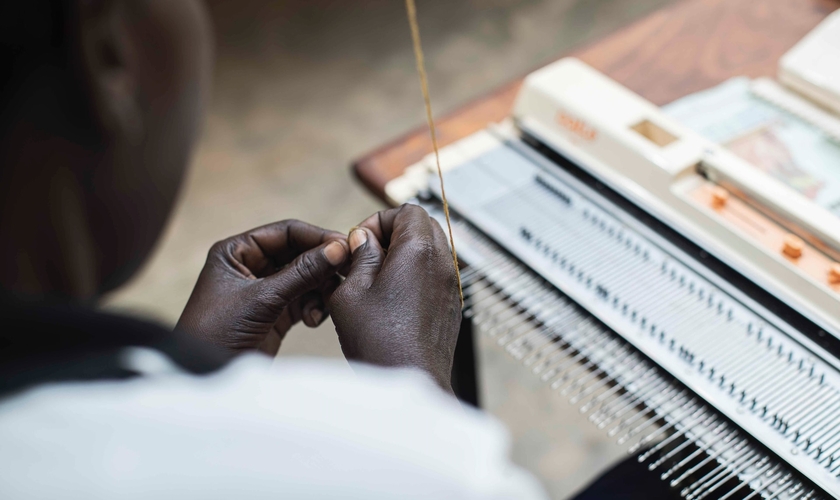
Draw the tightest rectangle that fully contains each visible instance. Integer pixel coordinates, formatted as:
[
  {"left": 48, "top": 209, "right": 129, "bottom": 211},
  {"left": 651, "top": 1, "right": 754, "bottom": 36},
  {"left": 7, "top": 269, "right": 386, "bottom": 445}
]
[{"left": 0, "top": 292, "right": 231, "bottom": 398}]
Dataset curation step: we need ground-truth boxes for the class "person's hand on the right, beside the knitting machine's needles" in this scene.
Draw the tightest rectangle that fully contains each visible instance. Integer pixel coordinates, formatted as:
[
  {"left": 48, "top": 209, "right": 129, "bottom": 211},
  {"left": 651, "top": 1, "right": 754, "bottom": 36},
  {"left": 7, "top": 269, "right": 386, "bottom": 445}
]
[{"left": 330, "top": 205, "right": 461, "bottom": 392}]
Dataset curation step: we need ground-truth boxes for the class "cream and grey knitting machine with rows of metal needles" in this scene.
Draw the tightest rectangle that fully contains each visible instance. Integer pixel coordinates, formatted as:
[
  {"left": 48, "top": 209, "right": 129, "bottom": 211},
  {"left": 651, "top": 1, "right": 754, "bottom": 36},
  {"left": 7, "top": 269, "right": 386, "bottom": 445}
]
[{"left": 386, "top": 59, "right": 840, "bottom": 500}]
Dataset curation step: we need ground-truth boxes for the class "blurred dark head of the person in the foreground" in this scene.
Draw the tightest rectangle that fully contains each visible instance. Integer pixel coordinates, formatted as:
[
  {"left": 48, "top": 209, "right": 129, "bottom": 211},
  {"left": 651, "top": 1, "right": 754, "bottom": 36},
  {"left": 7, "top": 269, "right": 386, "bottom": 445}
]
[{"left": 0, "top": 0, "right": 212, "bottom": 299}]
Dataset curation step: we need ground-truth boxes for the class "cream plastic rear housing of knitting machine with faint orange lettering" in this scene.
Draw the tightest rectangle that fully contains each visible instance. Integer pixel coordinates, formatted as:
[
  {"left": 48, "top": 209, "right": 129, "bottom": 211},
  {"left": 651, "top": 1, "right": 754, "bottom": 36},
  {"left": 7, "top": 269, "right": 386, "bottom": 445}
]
[{"left": 513, "top": 58, "right": 840, "bottom": 335}]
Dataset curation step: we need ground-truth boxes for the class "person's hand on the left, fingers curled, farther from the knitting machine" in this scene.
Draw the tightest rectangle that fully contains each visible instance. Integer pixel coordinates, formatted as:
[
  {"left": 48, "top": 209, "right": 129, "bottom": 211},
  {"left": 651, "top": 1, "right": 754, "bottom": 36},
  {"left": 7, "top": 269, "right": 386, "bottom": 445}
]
[{"left": 176, "top": 220, "right": 349, "bottom": 355}]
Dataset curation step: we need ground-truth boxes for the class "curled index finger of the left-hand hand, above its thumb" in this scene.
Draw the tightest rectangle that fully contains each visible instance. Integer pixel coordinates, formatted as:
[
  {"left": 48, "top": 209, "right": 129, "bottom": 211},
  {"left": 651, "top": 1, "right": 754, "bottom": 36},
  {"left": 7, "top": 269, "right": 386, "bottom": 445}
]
[{"left": 228, "top": 220, "right": 346, "bottom": 278}]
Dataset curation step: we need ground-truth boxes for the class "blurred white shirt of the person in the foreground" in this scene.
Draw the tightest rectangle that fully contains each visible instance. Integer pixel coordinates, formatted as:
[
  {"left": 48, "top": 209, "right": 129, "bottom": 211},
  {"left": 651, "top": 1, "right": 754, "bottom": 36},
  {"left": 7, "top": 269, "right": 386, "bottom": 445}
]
[{"left": 0, "top": 356, "right": 545, "bottom": 500}]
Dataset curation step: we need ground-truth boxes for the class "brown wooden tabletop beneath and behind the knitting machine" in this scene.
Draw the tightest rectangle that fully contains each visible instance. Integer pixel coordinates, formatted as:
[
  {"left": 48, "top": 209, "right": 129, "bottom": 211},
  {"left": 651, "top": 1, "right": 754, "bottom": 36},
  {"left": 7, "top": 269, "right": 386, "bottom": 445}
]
[{"left": 353, "top": 0, "right": 840, "bottom": 200}]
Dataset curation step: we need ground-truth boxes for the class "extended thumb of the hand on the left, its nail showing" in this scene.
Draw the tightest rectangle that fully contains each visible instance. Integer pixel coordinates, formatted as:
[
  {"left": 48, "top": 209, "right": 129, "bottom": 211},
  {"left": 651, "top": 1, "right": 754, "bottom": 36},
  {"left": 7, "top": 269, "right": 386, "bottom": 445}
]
[{"left": 266, "top": 241, "right": 350, "bottom": 307}]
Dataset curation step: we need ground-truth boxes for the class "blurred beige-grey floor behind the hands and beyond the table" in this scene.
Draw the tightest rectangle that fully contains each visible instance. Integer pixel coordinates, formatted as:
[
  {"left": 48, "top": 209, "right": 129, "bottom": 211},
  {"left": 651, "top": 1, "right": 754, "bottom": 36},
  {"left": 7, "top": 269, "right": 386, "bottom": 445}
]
[{"left": 101, "top": 0, "right": 673, "bottom": 498}]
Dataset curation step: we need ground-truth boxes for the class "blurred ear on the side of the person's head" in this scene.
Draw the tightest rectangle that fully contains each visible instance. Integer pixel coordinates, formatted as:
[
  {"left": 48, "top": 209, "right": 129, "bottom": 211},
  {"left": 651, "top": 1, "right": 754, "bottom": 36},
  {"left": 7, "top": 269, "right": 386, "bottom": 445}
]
[{"left": 74, "top": 0, "right": 144, "bottom": 144}]
